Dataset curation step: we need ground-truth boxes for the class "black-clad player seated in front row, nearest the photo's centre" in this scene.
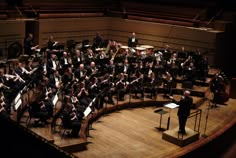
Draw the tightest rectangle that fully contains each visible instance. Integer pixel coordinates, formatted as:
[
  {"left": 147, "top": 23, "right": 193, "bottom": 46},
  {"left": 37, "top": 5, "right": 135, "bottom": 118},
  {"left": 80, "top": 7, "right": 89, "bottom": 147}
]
[{"left": 115, "top": 73, "right": 128, "bottom": 101}]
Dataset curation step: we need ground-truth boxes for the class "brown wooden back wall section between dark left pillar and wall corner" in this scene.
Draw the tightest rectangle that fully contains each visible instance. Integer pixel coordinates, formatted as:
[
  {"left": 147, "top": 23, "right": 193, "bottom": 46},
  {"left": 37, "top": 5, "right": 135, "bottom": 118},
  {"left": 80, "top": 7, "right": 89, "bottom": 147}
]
[{"left": 39, "top": 18, "right": 108, "bottom": 46}]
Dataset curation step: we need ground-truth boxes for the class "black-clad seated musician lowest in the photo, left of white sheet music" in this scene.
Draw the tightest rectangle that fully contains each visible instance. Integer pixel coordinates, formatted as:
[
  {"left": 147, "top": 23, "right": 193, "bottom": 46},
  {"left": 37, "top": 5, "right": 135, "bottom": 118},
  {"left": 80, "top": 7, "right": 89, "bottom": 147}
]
[{"left": 61, "top": 102, "right": 82, "bottom": 138}]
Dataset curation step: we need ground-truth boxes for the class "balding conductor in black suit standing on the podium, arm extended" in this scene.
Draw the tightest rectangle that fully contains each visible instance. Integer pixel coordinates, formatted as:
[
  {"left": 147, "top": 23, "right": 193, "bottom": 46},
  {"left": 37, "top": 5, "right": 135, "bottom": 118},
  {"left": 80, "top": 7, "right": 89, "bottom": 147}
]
[{"left": 170, "top": 90, "right": 193, "bottom": 134}]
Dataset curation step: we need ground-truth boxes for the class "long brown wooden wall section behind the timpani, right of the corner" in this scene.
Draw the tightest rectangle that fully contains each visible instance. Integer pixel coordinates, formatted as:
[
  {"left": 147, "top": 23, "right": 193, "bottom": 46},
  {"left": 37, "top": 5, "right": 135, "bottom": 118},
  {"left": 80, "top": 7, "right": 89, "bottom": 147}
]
[{"left": 109, "top": 18, "right": 221, "bottom": 52}]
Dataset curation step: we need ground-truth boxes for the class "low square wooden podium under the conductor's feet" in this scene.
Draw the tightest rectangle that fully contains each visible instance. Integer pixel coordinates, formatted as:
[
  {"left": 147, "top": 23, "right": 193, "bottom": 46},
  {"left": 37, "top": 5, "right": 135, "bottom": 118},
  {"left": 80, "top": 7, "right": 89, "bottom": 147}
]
[{"left": 162, "top": 127, "right": 199, "bottom": 147}]
